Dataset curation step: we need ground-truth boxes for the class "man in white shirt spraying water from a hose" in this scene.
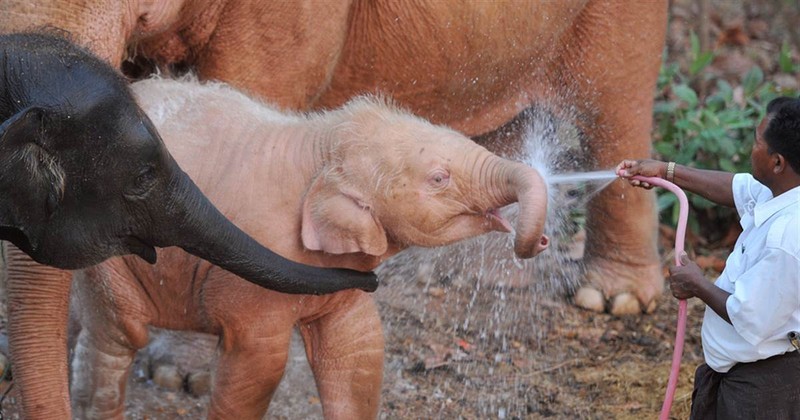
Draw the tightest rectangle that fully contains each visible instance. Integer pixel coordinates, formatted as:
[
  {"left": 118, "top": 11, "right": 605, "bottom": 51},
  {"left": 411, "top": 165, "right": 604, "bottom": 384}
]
[{"left": 617, "top": 97, "right": 800, "bottom": 419}]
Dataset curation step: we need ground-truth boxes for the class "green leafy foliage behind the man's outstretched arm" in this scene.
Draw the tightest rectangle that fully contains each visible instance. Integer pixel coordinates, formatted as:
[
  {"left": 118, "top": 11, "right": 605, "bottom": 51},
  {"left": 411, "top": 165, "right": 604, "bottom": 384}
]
[{"left": 654, "top": 34, "right": 800, "bottom": 234}]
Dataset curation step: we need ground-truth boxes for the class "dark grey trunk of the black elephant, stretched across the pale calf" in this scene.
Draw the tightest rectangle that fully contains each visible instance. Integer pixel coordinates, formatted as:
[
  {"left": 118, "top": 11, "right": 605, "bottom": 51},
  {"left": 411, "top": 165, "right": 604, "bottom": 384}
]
[{"left": 152, "top": 168, "right": 377, "bottom": 294}]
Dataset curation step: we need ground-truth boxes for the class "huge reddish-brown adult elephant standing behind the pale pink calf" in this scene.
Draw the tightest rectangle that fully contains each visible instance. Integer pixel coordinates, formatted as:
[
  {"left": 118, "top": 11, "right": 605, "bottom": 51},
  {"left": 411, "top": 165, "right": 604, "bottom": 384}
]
[{"left": 0, "top": 0, "right": 667, "bottom": 314}]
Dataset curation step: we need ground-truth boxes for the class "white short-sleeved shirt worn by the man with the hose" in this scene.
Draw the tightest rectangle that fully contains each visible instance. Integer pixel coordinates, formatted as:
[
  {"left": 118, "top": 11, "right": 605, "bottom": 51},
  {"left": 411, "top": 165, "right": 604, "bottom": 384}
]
[{"left": 702, "top": 174, "right": 800, "bottom": 373}]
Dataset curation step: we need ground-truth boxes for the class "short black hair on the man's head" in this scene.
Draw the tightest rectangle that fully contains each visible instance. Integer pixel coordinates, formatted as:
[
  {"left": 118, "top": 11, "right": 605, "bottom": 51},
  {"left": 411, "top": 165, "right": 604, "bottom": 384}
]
[{"left": 764, "top": 96, "right": 800, "bottom": 174}]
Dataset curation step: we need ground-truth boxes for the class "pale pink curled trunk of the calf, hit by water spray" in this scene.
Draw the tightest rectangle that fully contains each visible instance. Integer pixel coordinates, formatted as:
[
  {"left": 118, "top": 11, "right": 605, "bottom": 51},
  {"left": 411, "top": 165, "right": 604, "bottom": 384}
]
[{"left": 489, "top": 157, "right": 550, "bottom": 258}]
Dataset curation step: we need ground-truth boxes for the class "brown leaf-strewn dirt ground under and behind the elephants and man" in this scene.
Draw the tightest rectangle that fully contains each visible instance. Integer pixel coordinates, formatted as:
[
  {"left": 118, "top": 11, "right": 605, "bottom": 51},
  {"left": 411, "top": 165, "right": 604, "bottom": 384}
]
[{"left": 0, "top": 0, "right": 798, "bottom": 419}]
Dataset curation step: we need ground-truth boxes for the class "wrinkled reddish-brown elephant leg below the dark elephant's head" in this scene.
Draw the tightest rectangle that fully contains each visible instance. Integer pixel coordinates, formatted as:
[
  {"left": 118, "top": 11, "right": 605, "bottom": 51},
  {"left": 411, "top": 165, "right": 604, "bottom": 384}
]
[{"left": 5, "top": 243, "right": 72, "bottom": 419}]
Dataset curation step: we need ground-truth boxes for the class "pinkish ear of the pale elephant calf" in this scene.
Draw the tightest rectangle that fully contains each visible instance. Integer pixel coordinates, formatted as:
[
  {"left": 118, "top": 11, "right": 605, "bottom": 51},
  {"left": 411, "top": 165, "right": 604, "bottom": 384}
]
[{"left": 302, "top": 174, "right": 389, "bottom": 256}]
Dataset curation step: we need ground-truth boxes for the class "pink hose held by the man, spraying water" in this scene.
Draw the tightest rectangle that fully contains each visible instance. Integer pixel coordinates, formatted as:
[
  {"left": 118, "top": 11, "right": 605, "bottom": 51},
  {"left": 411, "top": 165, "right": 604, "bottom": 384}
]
[{"left": 632, "top": 175, "right": 689, "bottom": 420}]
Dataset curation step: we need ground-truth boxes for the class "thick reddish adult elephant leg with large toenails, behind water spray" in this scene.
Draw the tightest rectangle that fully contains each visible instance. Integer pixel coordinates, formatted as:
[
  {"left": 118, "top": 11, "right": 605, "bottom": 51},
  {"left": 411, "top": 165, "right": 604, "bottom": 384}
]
[{"left": 557, "top": 2, "right": 667, "bottom": 315}]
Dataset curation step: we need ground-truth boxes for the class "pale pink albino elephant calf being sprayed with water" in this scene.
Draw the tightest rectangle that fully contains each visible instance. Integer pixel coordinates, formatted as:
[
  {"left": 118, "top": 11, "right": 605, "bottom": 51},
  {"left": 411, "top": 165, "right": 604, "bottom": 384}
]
[{"left": 73, "top": 80, "right": 547, "bottom": 419}]
